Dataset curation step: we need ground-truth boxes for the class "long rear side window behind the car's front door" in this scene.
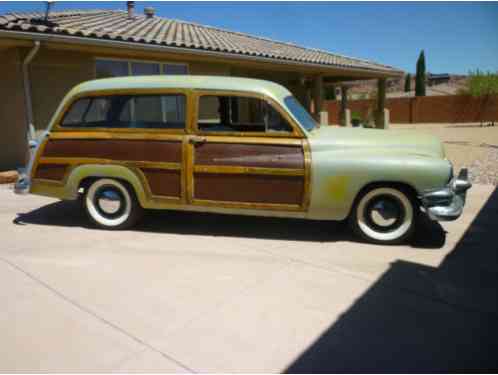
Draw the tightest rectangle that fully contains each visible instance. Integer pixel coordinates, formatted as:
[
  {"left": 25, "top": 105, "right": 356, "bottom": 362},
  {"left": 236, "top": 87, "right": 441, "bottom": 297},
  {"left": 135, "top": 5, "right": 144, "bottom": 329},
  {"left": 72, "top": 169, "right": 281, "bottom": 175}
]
[{"left": 61, "top": 95, "right": 185, "bottom": 129}]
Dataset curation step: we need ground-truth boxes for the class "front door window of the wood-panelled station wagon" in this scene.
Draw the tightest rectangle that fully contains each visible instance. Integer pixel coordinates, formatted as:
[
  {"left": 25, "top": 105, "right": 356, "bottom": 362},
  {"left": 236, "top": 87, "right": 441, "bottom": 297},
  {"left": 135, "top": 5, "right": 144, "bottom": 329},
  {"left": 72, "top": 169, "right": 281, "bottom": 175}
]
[{"left": 198, "top": 95, "right": 292, "bottom": 133}]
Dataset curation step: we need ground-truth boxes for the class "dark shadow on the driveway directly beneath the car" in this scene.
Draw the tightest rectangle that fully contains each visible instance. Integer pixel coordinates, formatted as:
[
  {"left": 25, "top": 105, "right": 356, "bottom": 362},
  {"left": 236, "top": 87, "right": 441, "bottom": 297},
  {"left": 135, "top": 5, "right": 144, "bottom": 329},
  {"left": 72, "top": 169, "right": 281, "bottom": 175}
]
[{"left": 14, "top": 201, "right": 446, "bottom": 249}]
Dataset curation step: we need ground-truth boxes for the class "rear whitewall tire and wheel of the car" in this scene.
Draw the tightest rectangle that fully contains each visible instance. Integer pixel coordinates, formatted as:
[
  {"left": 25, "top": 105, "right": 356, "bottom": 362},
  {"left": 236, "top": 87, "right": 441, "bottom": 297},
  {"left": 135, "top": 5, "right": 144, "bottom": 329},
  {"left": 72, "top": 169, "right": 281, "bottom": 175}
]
[{"left": 83, "top": 178, "right": 142, "bottom": 229}]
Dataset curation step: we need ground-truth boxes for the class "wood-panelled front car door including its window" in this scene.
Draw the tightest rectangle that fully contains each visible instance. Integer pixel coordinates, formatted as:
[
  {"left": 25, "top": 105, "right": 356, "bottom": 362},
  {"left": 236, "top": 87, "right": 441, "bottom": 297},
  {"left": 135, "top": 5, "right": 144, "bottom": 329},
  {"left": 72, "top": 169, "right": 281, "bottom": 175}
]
[{"left": 186, "top": 91, "right": 310, "bottom": 211}]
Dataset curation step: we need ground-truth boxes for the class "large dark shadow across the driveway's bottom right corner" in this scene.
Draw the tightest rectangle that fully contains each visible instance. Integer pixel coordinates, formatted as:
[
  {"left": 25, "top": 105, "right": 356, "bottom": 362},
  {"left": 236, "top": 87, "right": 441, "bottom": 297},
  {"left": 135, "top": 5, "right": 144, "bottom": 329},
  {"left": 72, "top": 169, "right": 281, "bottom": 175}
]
[{"left": 285, "top": 188, "right": 498, "bottom": 373}]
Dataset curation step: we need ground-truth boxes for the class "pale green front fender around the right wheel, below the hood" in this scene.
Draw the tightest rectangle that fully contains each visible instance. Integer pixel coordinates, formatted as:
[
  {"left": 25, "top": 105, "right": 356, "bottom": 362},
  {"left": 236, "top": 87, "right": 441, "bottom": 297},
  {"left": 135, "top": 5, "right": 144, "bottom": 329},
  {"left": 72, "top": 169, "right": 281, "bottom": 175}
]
[{"left": 308, "top": 150, "right": 451, "bottom": 220}]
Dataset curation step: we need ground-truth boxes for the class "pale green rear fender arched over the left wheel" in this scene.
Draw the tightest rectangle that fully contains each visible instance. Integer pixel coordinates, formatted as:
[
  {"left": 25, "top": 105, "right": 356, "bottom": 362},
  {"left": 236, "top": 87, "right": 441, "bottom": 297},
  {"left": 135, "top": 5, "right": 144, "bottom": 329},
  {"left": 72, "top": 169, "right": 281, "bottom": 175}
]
[{"left": 65, "top": 164, "right": 147, "bottom": 207}]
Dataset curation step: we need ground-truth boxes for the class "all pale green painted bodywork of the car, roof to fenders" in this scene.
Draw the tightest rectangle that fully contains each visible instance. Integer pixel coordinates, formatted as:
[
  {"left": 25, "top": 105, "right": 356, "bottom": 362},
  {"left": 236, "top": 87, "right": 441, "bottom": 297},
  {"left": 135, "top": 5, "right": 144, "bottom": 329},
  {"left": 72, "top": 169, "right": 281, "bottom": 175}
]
[{"left": 32, "top": 76, "right": 453, "bottom": 220}]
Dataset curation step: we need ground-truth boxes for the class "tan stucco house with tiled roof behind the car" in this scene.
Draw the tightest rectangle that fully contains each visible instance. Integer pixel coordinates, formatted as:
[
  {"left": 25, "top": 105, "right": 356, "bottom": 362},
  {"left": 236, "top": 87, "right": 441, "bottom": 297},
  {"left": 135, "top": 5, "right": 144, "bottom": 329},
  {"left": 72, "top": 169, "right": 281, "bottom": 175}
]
[{"left": 0, "top": 2, "right": 403, "bottom": 170}]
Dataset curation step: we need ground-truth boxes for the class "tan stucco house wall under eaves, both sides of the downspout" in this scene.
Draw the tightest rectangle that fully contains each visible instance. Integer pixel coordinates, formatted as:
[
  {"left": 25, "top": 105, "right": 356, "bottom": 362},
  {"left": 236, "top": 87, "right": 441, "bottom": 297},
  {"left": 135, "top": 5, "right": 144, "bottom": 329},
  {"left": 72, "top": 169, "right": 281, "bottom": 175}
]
[{"left": 0, "top": 43, "right": 304, "bottom": 169}]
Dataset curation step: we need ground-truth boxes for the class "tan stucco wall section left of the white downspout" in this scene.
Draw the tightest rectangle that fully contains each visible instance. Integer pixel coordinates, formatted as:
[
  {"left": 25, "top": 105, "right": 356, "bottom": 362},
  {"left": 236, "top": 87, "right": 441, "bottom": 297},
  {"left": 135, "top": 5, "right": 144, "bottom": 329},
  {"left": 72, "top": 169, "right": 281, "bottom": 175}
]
[{"left": 0, "top": 49, "right": 26, "bottom": 170}]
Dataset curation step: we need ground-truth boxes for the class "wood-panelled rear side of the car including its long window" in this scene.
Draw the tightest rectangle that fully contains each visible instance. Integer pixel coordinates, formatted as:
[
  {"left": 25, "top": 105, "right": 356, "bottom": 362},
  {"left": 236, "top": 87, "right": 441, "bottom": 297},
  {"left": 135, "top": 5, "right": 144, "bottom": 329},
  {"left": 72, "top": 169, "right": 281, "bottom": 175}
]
[{"left": 33, "top": 90, "right": 188, "bottom": 203}]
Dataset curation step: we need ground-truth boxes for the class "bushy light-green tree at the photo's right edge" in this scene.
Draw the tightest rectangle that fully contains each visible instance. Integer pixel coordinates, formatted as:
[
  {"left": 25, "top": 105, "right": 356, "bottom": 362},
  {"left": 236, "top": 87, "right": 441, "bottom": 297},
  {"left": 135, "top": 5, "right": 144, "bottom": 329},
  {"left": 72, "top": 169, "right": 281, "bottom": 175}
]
[{"left": 467, "top": 69, "right": 498, "bottom": 126}]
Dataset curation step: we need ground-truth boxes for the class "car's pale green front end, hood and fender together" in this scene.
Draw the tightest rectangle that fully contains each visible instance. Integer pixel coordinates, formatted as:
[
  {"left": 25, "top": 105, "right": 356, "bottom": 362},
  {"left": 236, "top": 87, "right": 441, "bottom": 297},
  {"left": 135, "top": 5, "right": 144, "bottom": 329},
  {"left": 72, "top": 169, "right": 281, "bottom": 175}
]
[{"left": 307, "top": 127, "right": 452, "bottom": 220}]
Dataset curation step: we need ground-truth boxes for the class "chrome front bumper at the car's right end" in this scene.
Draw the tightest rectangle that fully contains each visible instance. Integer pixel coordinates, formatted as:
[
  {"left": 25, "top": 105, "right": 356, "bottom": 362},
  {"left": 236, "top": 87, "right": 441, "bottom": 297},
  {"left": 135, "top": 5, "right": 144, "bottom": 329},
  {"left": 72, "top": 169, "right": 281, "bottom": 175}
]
[{"left": 421, "top": 168, "right": 472, "bottom": 221}]
